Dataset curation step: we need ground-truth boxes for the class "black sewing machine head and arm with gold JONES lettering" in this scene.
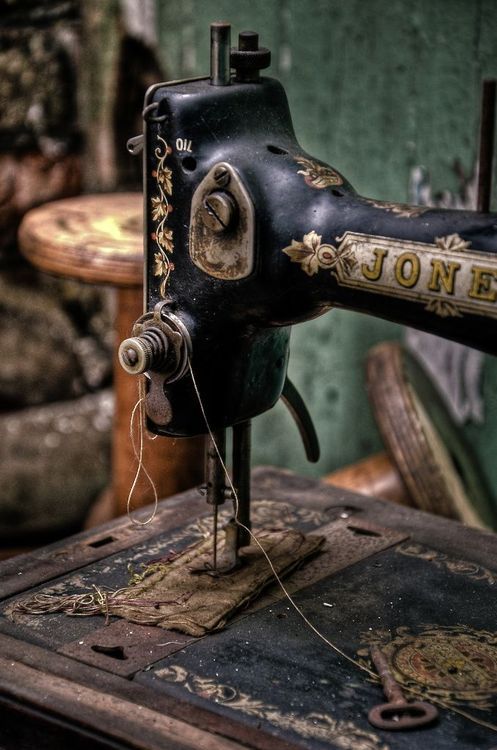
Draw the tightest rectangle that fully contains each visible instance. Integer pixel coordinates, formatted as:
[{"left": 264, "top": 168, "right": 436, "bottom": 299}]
[{"left": 120, "top": 24, "right": 497, "bottom": 572}]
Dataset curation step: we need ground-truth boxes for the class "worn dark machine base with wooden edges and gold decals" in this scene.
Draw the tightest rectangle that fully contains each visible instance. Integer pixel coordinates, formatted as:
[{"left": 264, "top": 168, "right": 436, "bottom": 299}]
[{"left": 0, "top": 469, "right": 497, "bottom": 750}]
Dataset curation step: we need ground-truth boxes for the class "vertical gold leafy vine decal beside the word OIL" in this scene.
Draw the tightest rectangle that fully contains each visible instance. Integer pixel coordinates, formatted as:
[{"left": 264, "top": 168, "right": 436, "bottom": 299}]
[{"left": 151, "top": 135, "right": 174, "bottom": 297}]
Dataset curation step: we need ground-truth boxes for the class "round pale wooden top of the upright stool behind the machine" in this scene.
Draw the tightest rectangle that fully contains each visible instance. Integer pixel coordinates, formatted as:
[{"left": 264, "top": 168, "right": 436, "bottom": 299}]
[{"left": 19, "top": 193, "right": 143, "bottom": 286}]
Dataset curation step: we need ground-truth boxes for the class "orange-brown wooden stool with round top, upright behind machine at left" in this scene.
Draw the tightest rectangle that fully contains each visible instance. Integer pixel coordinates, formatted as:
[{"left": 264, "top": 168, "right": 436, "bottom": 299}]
[{"left": 19, "top": 193, "right": 203, "bottom": 522}]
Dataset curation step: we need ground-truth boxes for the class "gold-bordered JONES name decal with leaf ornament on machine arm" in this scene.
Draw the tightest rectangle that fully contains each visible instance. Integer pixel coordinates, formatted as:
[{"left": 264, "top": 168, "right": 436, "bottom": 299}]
[{"left": 282, "top": 230, "right": 497, "bottom": 318}]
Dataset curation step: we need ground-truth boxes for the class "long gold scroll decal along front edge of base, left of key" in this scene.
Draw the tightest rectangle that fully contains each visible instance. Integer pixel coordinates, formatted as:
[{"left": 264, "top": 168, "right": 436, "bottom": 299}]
[{"left": 155, "top": 664, "right": 388, "bottom": 750}]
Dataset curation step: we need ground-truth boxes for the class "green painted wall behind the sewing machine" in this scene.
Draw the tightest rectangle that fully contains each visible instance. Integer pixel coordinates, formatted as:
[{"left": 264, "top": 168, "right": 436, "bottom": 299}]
[{"left": 157, "top": 0, "right": 497, "bottom": 494}]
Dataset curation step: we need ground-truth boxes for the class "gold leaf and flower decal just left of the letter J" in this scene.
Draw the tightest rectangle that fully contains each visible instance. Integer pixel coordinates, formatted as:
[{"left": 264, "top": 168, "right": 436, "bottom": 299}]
[{"left": 283, "top": 230, "right": 357, "bottom": 276}]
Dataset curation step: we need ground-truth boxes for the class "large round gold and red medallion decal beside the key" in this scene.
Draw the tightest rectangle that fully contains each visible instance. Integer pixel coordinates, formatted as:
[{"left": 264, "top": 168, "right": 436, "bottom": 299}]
[{"left": 357, "top": 625, "right": 497, "bottom": 711}]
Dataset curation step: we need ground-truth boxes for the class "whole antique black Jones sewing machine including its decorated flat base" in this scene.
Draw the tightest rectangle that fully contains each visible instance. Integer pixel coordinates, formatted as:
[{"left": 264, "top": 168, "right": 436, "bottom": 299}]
[{"left": 0, "top": 24, "right": 497, "bottom": 750}]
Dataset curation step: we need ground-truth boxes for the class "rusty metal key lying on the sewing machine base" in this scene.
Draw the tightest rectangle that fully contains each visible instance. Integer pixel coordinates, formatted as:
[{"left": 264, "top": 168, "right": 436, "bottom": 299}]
[{"left": 368, "top": 646, "right": 438, "bottom": 731}]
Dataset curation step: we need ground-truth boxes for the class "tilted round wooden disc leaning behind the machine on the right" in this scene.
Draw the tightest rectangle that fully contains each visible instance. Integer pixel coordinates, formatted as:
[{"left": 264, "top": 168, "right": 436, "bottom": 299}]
[{"left": 367, "top": 342, "right": 493, "bottom": 528}]
